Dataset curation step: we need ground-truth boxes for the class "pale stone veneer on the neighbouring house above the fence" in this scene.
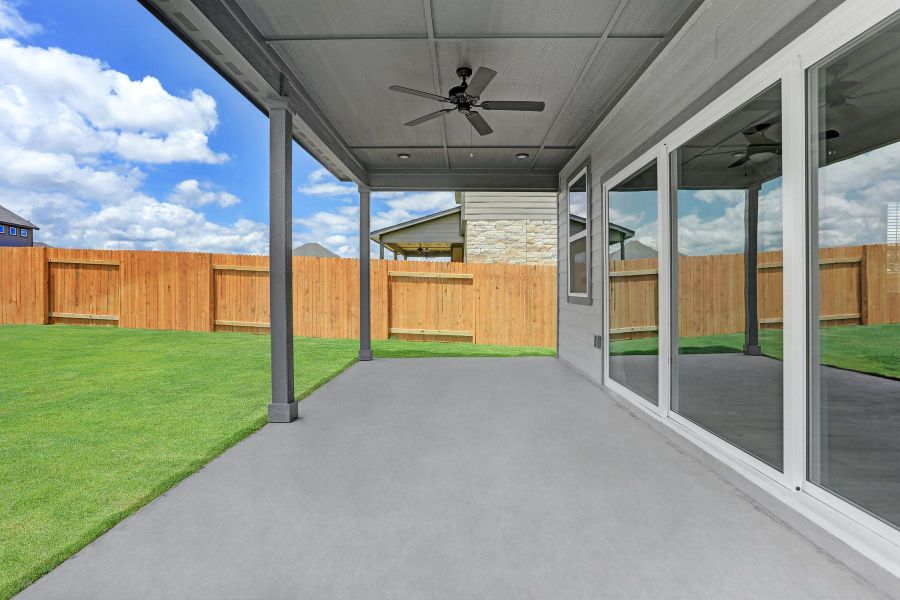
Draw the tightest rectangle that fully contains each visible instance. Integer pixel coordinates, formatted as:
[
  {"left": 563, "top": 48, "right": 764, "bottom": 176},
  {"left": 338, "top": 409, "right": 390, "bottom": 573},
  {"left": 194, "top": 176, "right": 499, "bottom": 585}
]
[{"left": 466, "top": 219, "right": 557, "bottom": 265}]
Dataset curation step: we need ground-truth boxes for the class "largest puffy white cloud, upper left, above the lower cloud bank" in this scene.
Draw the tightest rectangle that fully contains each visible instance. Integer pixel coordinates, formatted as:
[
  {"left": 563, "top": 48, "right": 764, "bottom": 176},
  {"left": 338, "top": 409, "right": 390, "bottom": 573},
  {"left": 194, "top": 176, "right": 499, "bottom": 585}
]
[{"left": 0, "top": 38, "right": 228, "bottom": 164}]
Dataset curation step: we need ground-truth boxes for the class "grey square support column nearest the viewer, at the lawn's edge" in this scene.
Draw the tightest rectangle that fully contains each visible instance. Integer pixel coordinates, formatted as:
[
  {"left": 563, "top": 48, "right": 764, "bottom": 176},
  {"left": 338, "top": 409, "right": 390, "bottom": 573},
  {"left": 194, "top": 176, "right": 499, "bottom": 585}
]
[{"left": 267, "top": 98, "right": 298, "bottom": 423}]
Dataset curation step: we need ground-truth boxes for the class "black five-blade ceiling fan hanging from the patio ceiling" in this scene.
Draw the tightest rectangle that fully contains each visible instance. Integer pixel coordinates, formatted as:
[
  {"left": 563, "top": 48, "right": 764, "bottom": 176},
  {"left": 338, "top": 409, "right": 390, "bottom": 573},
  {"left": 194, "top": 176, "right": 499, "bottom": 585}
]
[{"left": 388, "top": 67, "right": 544, "bottom": 135}]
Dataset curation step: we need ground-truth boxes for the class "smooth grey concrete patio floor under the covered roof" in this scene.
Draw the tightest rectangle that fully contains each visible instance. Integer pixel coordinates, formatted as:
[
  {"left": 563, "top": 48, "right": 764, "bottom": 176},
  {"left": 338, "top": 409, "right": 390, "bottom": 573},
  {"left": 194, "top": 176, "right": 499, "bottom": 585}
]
[{"left": 20, "top": 354, "right": 900, "bottom": 600}]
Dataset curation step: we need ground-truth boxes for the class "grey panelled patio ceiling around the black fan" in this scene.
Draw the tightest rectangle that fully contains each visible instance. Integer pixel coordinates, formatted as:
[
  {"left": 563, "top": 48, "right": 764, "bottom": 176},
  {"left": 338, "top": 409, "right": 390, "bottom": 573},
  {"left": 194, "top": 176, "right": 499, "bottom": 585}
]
[{"left": 141, "top": 0, "right": 700, "bottom": 190}]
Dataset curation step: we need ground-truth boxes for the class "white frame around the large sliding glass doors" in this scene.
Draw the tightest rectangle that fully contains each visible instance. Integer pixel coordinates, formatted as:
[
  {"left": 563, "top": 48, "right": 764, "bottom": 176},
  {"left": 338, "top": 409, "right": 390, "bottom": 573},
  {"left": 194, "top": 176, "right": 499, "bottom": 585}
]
[{"left": 566, "top": 0, "right": 900, "bottom": 576}]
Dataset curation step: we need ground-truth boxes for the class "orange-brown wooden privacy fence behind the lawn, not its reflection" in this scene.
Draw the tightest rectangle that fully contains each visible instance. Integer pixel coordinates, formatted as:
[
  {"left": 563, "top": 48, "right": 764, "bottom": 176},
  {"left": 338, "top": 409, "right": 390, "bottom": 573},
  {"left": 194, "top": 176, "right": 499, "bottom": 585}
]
[{"left": 0, "top": 248, "right": 556, "bottom": 347}]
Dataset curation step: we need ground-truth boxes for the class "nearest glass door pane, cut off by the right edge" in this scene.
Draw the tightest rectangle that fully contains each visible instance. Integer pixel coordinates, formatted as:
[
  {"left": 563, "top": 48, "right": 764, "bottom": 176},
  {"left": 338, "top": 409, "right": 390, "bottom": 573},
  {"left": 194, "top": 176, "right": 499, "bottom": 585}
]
[{"left": 809, "top": 16, "right": 900, "bottom": 526}]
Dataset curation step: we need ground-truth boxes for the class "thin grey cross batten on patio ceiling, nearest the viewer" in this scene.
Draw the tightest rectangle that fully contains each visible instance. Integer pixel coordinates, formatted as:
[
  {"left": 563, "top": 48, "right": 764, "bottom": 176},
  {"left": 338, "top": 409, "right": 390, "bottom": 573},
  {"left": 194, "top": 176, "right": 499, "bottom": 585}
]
[{"left": 264, "top": 33, "right": 666, "bottom": 43}]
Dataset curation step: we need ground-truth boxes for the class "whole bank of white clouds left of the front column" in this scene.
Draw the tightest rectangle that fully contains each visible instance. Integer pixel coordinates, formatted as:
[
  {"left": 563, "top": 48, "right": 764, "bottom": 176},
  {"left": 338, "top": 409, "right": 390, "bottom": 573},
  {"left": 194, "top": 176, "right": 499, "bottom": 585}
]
[{"left": 0, "top": 29, "right": 260, "bottom": 254}]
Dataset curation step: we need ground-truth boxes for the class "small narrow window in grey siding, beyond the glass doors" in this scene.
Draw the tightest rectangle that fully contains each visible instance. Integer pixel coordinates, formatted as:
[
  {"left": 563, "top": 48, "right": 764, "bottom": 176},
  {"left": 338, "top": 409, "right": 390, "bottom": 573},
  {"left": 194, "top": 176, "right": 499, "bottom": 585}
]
[{"left": 566, "top": 166, "right": 591, "bottom": 304}]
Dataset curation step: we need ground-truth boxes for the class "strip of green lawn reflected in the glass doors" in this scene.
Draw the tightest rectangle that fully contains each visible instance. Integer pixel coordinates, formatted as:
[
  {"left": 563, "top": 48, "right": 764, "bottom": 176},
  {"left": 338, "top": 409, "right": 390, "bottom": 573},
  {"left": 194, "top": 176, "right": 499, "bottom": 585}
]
[{"left": 610, "top": 324, "right": 900, "bottom": 379}]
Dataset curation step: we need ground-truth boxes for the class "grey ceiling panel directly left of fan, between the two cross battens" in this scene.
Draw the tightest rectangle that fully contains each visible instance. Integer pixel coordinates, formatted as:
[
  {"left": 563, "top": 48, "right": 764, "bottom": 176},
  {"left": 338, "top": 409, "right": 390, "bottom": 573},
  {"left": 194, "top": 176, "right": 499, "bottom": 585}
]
[{"left": 274, "top": 40, "right": 444, "bottom": 146}]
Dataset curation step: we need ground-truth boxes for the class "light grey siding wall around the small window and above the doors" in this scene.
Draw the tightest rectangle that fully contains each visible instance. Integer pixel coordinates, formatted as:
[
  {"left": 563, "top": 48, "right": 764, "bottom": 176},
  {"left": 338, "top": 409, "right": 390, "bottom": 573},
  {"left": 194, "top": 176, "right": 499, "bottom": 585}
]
[{"left": 558, "top": 0, "right": 841, "bottom": 382}]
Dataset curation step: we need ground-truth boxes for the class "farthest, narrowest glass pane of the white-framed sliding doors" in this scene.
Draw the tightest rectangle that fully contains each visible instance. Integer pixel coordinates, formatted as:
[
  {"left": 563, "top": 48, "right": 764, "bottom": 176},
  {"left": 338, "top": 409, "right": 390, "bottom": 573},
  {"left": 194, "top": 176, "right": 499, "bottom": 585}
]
[{"left": 608, "top": 161, "right": 659, "bottom": 404}]
